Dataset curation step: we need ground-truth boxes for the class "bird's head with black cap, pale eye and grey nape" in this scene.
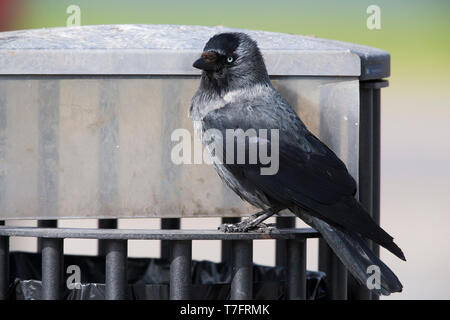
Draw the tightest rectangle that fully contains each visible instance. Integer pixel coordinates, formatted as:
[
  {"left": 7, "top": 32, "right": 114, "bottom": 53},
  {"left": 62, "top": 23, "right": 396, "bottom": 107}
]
[{"left": 193, "top": 32, "right": 269, "bottom": 91}]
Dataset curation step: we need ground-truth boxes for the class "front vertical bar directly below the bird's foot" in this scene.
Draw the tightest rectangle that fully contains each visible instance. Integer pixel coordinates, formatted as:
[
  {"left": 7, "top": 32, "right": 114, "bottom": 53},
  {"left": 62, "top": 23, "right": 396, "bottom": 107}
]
[{"left": 230, "top": 240, "right": 253, "bottom": 300}]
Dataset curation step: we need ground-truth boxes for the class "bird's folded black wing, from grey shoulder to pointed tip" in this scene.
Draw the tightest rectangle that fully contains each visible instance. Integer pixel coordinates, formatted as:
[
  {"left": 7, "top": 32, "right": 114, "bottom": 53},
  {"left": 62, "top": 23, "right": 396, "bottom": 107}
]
[{"left": 203, "top": 101, "right": 404, "bottom": 259}]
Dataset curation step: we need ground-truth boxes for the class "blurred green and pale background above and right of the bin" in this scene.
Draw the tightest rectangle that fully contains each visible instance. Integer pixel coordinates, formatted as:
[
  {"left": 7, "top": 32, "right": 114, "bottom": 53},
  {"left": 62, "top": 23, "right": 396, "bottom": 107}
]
[{"left": 0, "top": 0, "right": 450, "bottom": 299}]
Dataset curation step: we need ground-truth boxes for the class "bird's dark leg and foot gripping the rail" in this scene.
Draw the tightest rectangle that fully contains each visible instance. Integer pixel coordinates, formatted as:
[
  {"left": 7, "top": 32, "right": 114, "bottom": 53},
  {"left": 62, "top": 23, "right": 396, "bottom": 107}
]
[{"left": 217, "top": 208, "right": 282, "bottom": 232}]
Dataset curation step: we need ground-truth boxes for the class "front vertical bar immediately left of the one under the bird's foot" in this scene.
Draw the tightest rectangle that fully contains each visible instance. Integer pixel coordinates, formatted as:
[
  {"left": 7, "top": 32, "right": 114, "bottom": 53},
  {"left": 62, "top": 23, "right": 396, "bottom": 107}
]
[{"left": 169, "top": 240, "right": 192, "bottom": 300}]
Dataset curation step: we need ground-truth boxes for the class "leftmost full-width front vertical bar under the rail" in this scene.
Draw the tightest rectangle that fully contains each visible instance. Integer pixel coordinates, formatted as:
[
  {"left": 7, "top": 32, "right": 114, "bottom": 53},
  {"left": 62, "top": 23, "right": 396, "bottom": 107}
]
[{"left": 41, "top": 238, "right": 64, "bottom": 300}]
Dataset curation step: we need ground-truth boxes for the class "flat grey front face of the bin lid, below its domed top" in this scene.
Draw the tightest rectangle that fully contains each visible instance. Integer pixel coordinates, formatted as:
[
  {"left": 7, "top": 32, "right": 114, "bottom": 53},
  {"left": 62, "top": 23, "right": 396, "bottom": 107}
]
[{"left": 0, "top": 49, "right": 360, "bottom": 76}]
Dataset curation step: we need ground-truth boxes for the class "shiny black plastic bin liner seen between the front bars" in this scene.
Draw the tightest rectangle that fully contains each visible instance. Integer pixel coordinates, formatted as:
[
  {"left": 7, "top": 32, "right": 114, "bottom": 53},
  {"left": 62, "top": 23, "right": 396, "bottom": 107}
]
[{"left": 9, "top": 252, "right": 328, "bottom": 300}]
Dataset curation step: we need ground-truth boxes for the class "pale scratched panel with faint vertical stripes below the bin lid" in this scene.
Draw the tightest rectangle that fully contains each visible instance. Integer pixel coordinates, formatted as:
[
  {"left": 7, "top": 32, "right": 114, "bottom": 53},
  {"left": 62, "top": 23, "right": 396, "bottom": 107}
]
[{"left": 0, "top": 76, "right": 359, "bottom": 220}]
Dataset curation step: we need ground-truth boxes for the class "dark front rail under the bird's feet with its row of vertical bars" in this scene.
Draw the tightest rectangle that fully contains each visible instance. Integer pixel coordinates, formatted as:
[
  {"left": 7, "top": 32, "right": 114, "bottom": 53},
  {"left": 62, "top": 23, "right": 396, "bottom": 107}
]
[{"left": 0, "top": 222, "right": 319, "bottom": 300}]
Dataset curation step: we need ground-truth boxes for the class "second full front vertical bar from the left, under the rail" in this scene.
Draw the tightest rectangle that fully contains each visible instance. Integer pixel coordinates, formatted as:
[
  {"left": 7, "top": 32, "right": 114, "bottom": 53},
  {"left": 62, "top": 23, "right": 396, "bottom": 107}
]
[{"left": 105, "top": 240, "right": 128, "bottom": 300}]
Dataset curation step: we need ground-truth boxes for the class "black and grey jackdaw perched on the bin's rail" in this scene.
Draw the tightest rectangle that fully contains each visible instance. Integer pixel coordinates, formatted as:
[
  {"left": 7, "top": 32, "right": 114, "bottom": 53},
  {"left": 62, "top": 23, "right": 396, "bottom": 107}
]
[{"left": 190, "top": 33, "right": 405, "bottom": 295}]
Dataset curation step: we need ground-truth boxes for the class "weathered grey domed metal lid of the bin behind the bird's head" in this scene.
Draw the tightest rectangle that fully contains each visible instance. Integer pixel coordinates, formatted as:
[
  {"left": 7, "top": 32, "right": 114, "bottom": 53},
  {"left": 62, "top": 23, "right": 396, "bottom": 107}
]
[{"left": 0, "top": 25, "right": 390, "bottom": 80}]
